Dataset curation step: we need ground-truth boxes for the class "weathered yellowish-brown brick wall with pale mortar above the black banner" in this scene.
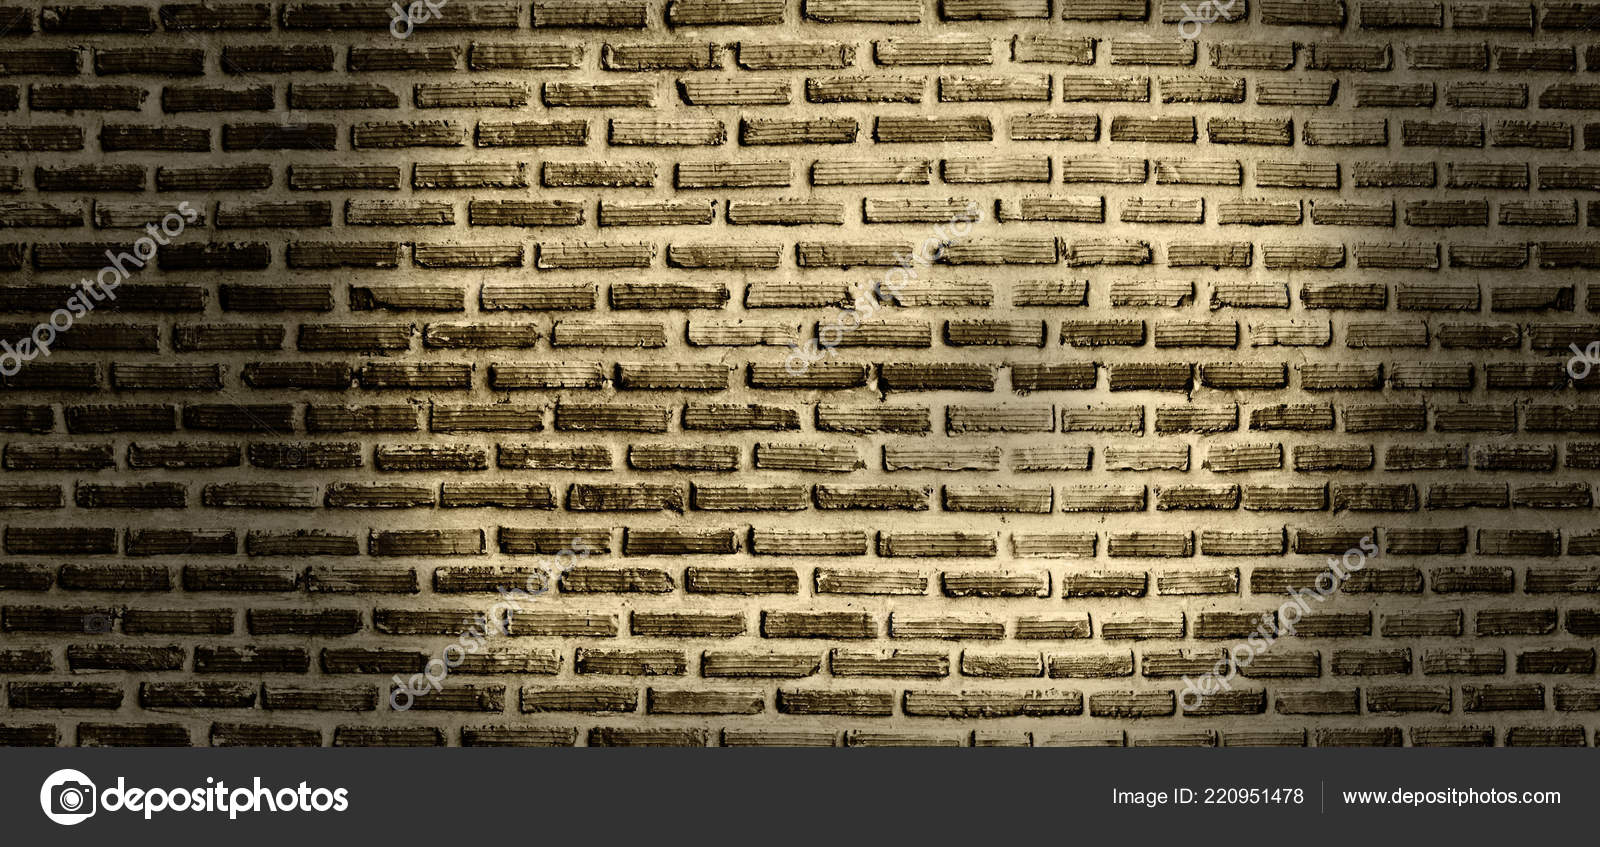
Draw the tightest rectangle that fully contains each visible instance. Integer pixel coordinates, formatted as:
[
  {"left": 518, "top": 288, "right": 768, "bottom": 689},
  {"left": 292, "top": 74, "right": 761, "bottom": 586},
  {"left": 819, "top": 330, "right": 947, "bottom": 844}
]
[{"left": 0, "top": 0, "right": 1600, "bottom": 746}]
